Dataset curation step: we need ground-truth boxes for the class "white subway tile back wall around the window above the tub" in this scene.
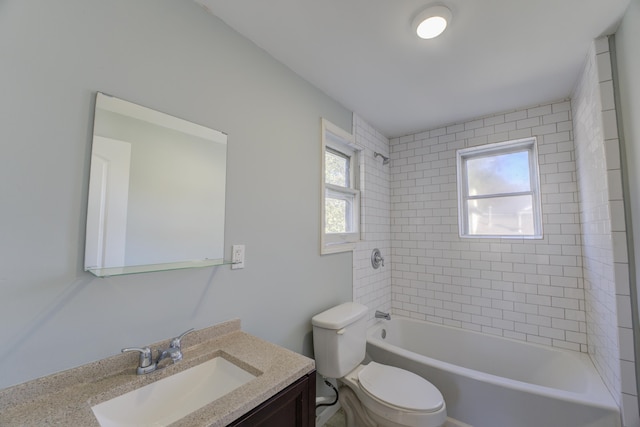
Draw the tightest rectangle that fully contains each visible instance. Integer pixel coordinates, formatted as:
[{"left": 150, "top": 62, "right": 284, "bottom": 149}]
[{"left": 390, "top": 99, "right": 587, "bottom": 352}]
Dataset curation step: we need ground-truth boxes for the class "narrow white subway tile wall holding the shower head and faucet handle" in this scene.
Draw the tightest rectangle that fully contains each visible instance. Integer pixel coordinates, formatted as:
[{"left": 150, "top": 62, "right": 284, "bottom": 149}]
[{"left": 353, "top": 114, "right": 391, "bottom": 324}]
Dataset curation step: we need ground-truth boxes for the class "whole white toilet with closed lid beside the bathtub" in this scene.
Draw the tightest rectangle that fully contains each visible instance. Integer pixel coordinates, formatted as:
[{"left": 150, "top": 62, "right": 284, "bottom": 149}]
[{"left": 311, "top": 302, "right": 447, "bottom": 427}]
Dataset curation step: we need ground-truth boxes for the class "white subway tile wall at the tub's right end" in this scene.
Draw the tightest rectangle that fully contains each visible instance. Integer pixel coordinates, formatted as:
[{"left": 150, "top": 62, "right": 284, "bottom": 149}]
[{"left": 572, "top": 37, "right": 639, "bottom": 425}]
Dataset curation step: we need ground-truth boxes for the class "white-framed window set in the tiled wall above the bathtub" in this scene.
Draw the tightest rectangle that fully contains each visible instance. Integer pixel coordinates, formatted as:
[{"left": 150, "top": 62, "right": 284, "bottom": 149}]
[{"left": 457, "top": 138, "right": 542, "bottom": 239}]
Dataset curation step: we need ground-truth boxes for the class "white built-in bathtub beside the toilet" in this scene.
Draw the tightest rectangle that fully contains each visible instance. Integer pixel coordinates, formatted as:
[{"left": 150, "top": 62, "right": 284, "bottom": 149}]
[{"left": 367, "top": 316, "right": 621, "bottom": 427}]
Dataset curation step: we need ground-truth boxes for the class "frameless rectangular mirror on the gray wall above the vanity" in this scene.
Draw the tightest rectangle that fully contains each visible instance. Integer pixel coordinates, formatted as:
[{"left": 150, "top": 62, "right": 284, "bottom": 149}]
[{"left": 85, "top": 93, "right": 227, "bottom": 276}]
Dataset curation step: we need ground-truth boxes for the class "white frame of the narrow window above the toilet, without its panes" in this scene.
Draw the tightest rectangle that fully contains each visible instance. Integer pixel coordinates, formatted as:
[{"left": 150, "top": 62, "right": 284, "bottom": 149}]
[{"left": 320, "top": 118, "right": 362, "bottom": 255}]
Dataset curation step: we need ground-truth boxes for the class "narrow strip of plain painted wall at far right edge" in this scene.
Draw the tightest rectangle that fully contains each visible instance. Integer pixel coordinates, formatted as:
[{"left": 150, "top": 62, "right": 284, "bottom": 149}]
[{"left": 615, "top": 0, "right": 640, "bottom": 426}]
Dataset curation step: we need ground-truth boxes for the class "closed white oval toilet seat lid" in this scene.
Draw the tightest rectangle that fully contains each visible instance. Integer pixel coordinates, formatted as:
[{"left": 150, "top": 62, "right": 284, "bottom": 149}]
[{"left": 358, "top": 362, "right": 444, "bottom": 413}]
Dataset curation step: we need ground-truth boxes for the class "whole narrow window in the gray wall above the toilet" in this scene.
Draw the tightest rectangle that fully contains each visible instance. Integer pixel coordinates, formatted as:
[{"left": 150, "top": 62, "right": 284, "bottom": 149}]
[{"left": 320, "top": 119, "right": 360, "bottom": 254}]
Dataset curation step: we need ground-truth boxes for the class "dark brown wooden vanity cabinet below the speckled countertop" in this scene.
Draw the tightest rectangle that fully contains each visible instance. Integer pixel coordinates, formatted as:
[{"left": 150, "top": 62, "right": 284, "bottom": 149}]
[{"left": 229, "top": 371, "right": 316, "bottom": 427}]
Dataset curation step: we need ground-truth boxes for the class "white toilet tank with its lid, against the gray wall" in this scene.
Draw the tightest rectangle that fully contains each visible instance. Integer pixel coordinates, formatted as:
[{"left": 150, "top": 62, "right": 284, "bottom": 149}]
[{"left": 311, "top": 302, "right": 368, "bottom": 378}]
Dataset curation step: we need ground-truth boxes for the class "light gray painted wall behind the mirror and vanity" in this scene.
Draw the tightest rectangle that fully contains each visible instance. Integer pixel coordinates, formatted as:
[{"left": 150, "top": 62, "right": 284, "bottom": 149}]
[{"left": 0, "top": 0, "right": 352, "bottom": 388}]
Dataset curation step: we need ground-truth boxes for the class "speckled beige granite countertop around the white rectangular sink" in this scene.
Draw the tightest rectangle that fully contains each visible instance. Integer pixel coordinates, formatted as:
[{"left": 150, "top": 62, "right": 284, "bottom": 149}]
[{"left": 0, "top": 319, "right": 315, "bottom": 427}]
